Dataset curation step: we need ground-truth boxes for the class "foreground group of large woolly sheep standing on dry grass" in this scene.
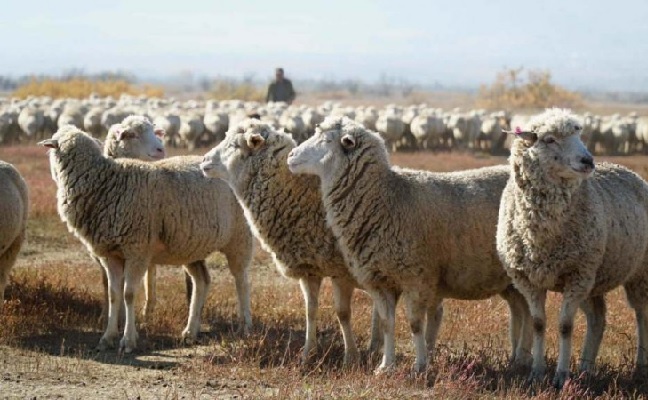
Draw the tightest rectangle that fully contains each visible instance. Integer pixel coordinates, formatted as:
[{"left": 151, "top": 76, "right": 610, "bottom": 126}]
[{"left": 0, "top": 109, "right": 648, "bottom": 387}]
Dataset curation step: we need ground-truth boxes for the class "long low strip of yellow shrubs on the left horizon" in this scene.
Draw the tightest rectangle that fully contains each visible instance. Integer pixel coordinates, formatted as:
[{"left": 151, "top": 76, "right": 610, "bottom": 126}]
[{"left": 12, "top": 78, "right": 164, "bottom": 99}]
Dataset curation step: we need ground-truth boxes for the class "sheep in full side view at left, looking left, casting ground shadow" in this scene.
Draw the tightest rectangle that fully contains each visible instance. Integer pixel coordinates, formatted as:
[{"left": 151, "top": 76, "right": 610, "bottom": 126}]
[{"left": 40, "top": 126, "right": 253, "bottom": 353}]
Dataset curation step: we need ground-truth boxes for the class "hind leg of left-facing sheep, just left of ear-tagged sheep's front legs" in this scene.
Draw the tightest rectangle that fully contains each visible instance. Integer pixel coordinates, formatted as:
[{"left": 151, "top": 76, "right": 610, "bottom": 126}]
[{"left": 500, "top": 285, "right": 533, "bottom": 367}]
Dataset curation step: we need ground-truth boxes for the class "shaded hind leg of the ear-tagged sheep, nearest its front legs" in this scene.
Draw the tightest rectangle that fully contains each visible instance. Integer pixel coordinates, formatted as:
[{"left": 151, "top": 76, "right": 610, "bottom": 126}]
[{"left": 580, "top": 296, "right": 605, "bottom": 372}]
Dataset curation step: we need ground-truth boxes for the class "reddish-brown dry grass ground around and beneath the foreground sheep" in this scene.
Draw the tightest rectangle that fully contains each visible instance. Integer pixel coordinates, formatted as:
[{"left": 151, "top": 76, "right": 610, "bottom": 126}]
[{"left": 0, "top": 145, "right": 648, "bottom": 399}]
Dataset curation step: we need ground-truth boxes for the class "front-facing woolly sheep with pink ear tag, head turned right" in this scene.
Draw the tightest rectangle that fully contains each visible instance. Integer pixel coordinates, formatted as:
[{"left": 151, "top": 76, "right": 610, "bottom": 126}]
[{"left": 497, "top": 108, "right": 648, "bottom": 388}]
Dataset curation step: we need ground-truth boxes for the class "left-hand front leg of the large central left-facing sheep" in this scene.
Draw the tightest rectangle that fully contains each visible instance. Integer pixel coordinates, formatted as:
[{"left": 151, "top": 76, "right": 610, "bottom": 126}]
[{"left": 367, "top": 288, "right": 397, "bottom": 374}]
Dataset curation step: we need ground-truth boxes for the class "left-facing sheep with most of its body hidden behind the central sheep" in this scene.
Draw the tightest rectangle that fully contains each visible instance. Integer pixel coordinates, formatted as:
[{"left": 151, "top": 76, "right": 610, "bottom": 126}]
[{"left": 201, "top": 120, "right": 378, "bottom": 364}]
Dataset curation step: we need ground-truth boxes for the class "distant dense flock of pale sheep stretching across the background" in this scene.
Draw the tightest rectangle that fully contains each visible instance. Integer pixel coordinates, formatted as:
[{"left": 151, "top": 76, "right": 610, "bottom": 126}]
[{"left": 0, "top": 95, "right": 648, "bottom": 155}]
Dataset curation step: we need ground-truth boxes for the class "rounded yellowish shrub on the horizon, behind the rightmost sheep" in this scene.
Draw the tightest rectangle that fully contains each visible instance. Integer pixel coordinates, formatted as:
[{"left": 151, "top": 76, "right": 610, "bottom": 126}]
[{"left": 477, "top": 68, "right": 583, "bottom": 110}]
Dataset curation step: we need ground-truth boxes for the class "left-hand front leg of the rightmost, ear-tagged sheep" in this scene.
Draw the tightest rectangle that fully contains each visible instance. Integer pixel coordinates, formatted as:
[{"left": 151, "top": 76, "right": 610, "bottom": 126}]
[{"left": 522, "top": 288, "right": 547, "bottom": 382}]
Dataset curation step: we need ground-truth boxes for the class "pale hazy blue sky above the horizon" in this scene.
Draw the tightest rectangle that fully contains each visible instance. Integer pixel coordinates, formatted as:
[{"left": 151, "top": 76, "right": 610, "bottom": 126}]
[{"left": 0, "top": 0, "right": 648, "bottom": 91}]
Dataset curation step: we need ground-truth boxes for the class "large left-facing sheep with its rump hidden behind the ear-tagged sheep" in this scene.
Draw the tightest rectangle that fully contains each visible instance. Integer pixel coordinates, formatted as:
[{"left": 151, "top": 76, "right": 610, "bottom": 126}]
[{"left": 287, "top": 118, "right": 531, "bottom": 373}]
